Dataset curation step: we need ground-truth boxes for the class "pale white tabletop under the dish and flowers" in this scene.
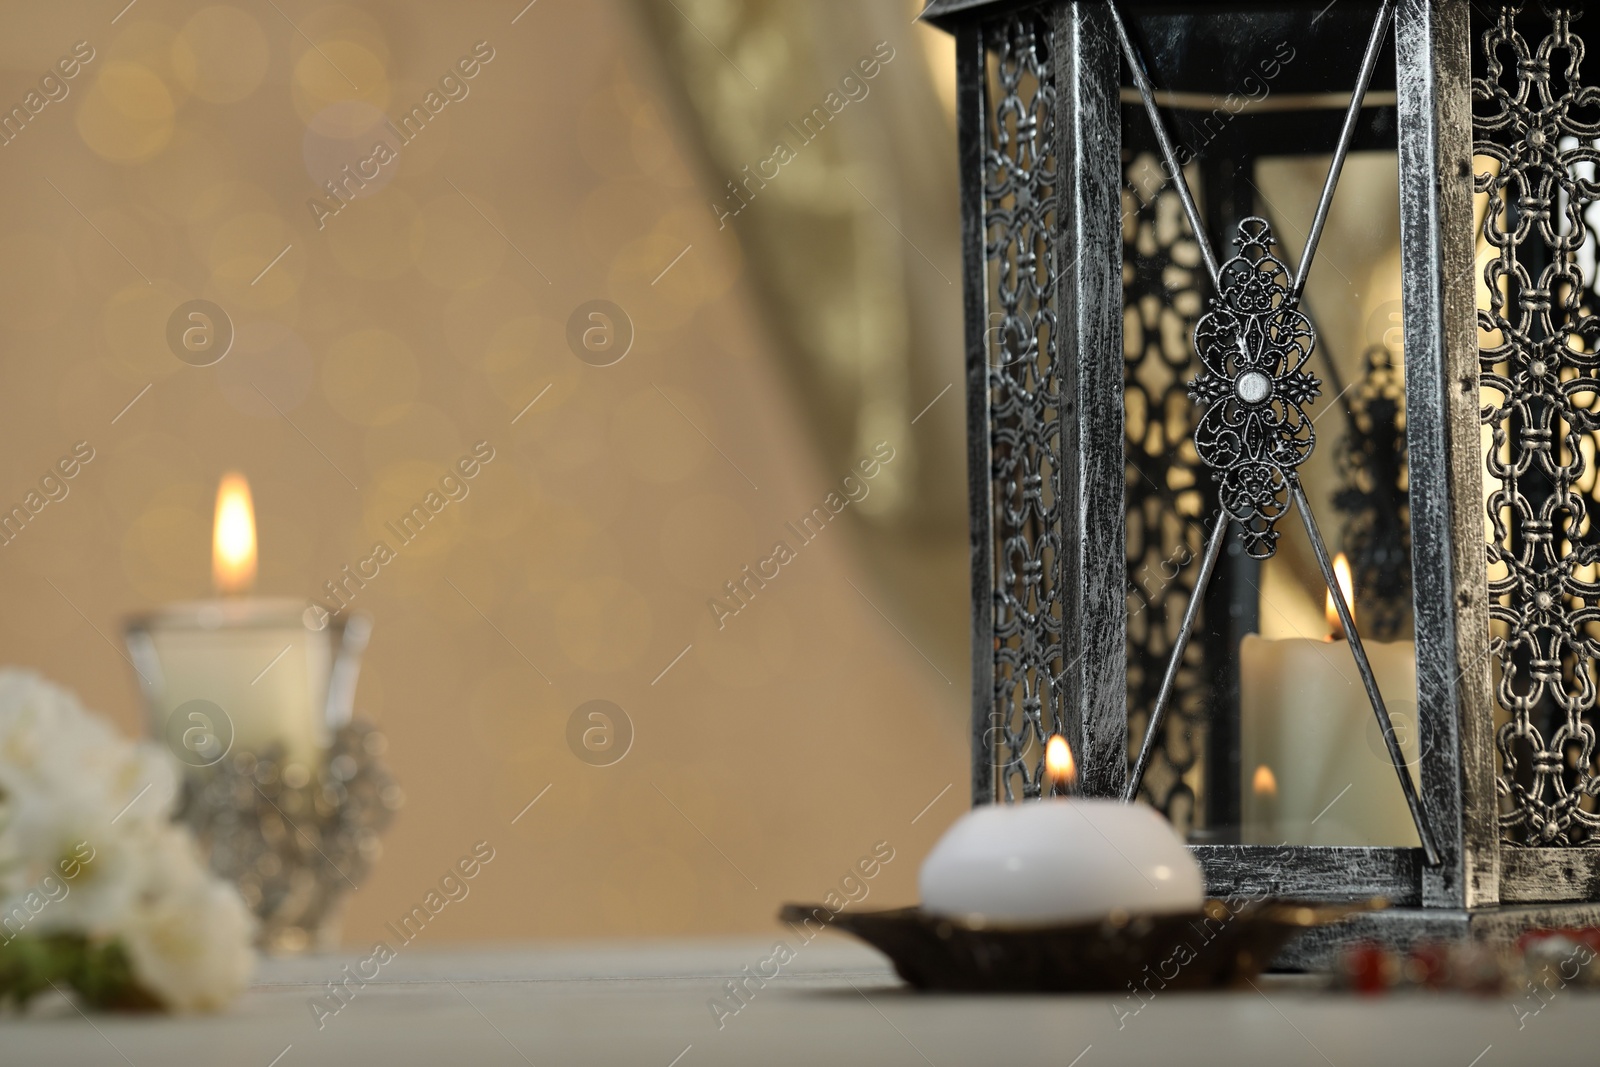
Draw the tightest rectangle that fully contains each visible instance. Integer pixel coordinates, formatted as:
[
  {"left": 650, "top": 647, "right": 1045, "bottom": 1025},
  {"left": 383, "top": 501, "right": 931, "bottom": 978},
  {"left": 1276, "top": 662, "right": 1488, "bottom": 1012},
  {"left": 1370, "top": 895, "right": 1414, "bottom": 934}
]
[{"left": 0, "top": 934, "right": 1600, "bottom": 1067}]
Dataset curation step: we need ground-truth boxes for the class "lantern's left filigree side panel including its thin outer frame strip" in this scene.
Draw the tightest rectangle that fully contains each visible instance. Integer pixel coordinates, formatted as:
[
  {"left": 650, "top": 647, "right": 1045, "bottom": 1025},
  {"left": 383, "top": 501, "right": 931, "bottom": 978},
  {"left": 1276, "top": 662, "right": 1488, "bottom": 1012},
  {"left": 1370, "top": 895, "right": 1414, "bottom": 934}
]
[{"left": 962, "top": 13, "right": 1066, "bottom": 803}]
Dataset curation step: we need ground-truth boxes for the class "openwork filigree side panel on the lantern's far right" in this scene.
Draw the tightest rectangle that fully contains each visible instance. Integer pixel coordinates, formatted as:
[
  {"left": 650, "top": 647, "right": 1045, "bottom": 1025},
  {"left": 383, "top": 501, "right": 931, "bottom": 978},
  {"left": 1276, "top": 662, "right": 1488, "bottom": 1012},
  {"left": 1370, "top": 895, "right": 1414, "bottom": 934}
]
[{"left": 1472, "top": 5, "right": 1600, "bottom": 846}]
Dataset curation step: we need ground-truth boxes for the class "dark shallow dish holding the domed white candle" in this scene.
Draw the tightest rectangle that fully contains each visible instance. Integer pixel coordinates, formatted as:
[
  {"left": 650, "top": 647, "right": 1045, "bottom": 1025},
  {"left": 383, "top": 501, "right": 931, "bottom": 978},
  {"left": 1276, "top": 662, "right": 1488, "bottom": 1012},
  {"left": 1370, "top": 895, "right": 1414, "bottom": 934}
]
[{"left": 778, "top": 901, "right": 1381, "bottom": 993}]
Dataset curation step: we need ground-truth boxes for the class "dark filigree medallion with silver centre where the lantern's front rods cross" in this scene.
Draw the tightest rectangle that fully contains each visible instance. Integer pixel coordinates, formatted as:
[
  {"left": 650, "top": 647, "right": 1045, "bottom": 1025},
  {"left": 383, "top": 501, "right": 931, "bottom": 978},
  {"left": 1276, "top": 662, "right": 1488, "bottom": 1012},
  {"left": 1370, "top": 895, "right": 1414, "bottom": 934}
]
[{"left": 1189, "top": 216, "right": 1322, "bottom": 560}]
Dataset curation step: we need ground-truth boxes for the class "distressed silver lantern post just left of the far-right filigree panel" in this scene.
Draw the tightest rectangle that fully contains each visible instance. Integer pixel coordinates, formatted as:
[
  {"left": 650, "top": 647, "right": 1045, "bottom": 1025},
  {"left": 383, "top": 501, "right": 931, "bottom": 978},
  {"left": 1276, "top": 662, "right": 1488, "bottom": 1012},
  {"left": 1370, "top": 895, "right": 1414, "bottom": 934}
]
[{"left": 1395, "top": 0, "right": 1501, "bottom": 909}]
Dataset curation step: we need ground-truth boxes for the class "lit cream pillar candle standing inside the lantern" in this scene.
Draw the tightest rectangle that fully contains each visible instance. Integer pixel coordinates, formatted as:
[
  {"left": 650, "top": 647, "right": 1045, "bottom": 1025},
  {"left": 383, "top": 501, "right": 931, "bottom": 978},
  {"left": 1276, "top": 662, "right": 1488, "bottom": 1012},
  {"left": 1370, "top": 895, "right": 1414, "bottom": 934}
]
[{"left": 1238, "top": 552, "right": 1419, "bottom": 846}]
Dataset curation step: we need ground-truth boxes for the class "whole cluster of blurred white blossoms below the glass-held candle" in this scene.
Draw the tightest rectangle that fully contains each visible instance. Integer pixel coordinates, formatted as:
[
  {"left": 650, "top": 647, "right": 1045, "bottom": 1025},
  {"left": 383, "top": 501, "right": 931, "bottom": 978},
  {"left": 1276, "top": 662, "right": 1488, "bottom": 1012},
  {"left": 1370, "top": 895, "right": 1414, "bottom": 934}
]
[{"left": 0, "top": 667, "right": 254, "bottom": 1011}]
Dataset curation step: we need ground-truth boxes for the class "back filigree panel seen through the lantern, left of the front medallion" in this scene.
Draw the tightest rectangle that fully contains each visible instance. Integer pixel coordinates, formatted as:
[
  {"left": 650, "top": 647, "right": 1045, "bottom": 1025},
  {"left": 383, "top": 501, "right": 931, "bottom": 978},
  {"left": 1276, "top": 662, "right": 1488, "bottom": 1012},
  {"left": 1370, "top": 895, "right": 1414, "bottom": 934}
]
[{"left": 1122, "top": 155, "right": 1211, "bottom": 832}]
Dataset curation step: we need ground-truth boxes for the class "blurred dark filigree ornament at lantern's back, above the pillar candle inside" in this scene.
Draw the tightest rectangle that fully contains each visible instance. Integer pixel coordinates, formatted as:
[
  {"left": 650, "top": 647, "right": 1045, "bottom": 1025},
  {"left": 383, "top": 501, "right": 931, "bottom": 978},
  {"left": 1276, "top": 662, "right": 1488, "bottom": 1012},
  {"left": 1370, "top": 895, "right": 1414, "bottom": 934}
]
[{"left": 1333, "top": 344, "right": 1411, "bottom": 641}]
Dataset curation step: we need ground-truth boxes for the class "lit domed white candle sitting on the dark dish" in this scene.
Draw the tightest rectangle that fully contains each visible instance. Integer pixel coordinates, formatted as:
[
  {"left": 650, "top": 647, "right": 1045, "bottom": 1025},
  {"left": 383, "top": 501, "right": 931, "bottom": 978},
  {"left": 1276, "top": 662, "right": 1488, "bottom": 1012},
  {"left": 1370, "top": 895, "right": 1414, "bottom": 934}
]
[{"left": 920, "top": 734, "right": 1203, "bottom": 923}]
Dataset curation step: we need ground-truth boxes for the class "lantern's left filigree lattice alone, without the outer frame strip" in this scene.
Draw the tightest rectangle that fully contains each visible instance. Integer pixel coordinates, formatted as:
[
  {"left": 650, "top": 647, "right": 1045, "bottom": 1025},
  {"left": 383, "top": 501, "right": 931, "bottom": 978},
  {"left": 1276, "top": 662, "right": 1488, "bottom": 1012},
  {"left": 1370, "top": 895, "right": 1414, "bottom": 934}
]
[{"left": 982, "top": 14, "right": 1066, "bottom": 801}]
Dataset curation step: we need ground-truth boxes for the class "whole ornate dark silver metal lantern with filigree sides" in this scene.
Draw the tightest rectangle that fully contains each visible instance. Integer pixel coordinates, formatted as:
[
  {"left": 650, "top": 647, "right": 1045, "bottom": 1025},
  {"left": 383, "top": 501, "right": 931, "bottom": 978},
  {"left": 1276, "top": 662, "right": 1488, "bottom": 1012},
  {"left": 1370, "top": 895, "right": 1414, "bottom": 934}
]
[{"left": 923, "top": 0, "right": 1600, "bottom": 963}]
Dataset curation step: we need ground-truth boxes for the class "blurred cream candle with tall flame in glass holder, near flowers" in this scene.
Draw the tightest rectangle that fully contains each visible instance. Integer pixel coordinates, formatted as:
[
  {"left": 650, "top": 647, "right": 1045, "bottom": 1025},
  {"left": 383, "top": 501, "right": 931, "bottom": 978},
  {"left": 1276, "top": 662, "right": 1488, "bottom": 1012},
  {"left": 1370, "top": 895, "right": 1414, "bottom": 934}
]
[{"left": 126, "top": 474, "right": 333, "bottom": 784}]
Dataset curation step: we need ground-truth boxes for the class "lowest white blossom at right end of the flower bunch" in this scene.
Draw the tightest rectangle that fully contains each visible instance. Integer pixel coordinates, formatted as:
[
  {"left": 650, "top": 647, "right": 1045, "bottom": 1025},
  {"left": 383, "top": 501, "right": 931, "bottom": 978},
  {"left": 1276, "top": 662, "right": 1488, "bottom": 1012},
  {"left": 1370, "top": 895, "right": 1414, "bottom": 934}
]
[{"left": 118, "top": 827, "right": 256, "bottom": 1011}]
